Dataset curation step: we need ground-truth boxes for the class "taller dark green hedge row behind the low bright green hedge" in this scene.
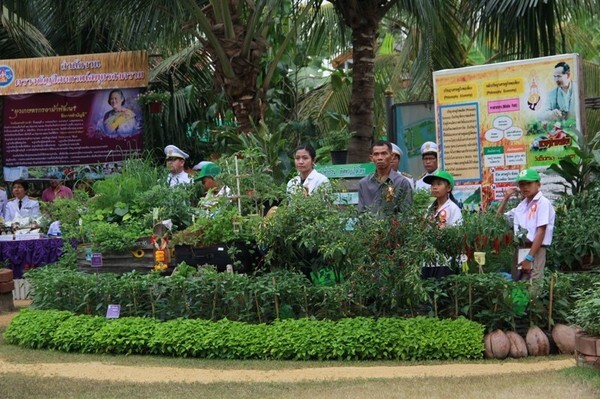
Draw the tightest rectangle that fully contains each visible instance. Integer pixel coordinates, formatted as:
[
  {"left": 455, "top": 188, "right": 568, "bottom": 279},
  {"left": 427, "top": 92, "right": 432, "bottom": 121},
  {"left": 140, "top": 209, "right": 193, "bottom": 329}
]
[{"left": 27, "top": 266, "right": 600, "bottom": 331}]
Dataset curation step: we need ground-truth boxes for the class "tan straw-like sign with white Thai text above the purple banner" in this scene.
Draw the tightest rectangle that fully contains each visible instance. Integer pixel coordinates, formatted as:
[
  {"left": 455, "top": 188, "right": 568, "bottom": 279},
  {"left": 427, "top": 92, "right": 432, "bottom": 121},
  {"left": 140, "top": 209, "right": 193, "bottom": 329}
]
[{"left": 0, "top": 51, "right": 148, "bottom": 96}]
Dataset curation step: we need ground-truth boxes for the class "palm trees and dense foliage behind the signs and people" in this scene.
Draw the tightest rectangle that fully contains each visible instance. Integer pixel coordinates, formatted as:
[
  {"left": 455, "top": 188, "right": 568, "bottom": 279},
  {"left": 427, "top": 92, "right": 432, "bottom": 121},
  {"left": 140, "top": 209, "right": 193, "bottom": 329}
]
[{"left": 0, "top": 0, "right": 600, "bottom": 166}]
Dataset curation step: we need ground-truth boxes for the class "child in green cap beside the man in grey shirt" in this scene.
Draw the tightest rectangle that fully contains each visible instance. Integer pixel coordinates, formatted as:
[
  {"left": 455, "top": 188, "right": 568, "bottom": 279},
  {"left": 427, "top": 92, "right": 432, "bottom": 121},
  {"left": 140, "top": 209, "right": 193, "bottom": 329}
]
[{"left": 421, "top": 169, "right": 462, "bottom": 278}]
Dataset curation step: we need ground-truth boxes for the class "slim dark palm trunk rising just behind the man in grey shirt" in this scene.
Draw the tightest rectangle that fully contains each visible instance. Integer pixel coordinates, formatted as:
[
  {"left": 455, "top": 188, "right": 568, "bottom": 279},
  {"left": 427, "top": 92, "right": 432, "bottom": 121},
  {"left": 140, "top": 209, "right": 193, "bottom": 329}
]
[{"left": 348, "top": 18, "right": 379, "bottom": 163}]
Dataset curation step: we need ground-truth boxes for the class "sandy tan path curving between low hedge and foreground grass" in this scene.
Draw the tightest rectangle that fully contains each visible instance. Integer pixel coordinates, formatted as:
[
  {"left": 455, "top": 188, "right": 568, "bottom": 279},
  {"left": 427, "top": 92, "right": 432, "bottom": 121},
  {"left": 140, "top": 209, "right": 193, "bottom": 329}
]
[{"left": 0, "top": 301, "right": 575, "bottom": 384}]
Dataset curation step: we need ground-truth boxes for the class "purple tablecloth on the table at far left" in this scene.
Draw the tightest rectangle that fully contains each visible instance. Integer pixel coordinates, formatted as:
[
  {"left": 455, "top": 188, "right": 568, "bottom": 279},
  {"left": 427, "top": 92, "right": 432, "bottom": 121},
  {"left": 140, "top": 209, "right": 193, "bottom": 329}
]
[{"left": 0, "top": 238, "right": 63, "bottom": 278}]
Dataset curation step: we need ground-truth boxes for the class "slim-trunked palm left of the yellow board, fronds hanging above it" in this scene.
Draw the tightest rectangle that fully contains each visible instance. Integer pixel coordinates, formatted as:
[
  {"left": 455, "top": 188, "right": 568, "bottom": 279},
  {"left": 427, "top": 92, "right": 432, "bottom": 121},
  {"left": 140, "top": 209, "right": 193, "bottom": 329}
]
[{"left": 330, "top": 0, "right": 600, "bottom": 162}]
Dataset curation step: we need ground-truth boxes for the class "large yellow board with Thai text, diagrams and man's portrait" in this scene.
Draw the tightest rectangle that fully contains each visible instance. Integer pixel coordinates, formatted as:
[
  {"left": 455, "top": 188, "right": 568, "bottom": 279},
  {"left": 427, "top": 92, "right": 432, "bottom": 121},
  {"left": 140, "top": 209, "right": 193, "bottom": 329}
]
[{"left": 433, "top": 54, "right": 584, "bottom": 210}]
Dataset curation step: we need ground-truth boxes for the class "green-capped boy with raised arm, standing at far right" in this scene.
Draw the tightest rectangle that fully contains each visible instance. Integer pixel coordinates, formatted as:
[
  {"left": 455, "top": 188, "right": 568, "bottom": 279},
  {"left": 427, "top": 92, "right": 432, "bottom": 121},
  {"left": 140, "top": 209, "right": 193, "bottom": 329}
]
[{"left": 498, "top": 169, "right": 555, "bottom": 280}]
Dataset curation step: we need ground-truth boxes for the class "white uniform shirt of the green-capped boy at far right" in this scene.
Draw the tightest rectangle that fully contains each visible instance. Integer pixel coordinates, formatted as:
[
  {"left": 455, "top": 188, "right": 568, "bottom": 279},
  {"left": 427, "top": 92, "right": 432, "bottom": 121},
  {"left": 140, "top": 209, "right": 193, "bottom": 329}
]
[{"left": 504, "top": 191, "right": 556, "bottom": 246}]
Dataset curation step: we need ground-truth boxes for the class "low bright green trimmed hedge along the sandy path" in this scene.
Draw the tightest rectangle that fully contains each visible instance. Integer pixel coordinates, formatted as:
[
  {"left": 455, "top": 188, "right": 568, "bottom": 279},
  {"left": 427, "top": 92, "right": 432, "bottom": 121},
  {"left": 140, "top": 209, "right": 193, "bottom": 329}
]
[{"left": 4, "top": 310, "right": 484, "bottom": 360}]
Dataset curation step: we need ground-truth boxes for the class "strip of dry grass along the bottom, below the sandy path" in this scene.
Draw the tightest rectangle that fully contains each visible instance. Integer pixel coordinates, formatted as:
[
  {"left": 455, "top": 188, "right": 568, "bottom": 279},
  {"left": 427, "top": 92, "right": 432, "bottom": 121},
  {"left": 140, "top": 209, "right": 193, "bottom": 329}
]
[{"left": 0, "top": 365, "right": 600, "bottom": 399}]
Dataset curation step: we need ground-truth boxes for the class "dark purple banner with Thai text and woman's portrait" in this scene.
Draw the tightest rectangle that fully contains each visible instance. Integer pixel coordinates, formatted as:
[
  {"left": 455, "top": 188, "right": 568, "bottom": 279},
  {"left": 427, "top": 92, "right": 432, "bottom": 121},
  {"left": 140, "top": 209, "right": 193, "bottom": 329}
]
[{"left": 2, "top": 89, "right": 143, "bottom": 178}]
